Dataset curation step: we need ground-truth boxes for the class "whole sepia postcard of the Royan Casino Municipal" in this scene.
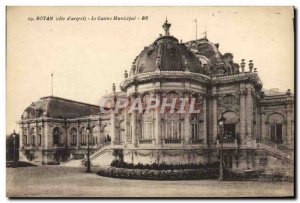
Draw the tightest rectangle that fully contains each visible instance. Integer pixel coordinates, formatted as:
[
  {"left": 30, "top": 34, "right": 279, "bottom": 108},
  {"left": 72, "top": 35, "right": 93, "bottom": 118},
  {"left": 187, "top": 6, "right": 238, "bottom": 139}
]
[{"left": 6, "top": 6, "right": 295, "bottom": 198}]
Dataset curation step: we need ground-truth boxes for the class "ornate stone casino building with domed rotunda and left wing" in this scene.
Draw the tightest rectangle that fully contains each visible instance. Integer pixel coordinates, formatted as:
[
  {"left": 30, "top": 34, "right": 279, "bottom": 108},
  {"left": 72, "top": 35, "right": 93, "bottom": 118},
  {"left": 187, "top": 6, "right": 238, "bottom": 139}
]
[{"left": 19, "top": 21, "right": 294, "bottom": 174}]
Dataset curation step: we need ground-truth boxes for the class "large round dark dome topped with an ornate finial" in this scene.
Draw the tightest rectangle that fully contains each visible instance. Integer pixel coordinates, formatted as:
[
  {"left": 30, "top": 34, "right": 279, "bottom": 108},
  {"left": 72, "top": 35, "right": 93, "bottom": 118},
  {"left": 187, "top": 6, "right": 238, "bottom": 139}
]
[{"left": 131, "top": 20, "right": 201, "bottom": 74}]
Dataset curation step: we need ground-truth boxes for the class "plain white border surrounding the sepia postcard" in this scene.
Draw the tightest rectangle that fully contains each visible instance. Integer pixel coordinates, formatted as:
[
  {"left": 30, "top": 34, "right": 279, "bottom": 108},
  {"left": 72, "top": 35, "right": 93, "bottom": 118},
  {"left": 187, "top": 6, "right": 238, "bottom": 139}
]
[{"left": 0, "top": 0, "right": 300, "bottom": 202}]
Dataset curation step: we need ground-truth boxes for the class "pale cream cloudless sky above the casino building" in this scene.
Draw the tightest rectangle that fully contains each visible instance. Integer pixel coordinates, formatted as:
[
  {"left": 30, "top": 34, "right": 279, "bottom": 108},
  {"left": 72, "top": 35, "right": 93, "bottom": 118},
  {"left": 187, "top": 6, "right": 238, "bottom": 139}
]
[{"left": 6, "top": 7, "right": 294, "bottom": 133}]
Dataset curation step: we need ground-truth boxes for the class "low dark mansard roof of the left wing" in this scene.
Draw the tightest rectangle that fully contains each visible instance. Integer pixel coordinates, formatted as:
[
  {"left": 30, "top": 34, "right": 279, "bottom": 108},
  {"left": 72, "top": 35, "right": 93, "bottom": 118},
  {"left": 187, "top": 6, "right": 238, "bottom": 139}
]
[{"left": 23, "top": 96, "right": 99, "bottom": 119}]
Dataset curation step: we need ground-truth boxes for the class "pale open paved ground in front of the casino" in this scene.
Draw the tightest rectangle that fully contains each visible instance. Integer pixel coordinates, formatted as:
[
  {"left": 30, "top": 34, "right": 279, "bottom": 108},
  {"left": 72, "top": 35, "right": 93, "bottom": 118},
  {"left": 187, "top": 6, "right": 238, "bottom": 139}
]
[{"left": 6, "top": 166, "right": 293, "bottom": 197}]
